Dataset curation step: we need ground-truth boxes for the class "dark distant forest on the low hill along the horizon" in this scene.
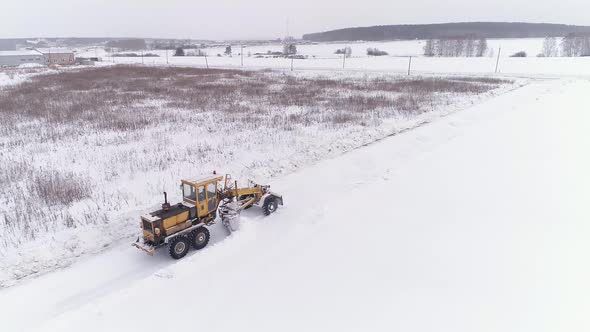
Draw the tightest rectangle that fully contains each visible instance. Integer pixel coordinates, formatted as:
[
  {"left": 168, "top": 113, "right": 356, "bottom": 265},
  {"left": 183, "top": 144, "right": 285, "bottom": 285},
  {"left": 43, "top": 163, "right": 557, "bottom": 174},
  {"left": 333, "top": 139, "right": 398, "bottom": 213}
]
[{"left": 303, "top": 22, "right": 590, "bottom": 41}]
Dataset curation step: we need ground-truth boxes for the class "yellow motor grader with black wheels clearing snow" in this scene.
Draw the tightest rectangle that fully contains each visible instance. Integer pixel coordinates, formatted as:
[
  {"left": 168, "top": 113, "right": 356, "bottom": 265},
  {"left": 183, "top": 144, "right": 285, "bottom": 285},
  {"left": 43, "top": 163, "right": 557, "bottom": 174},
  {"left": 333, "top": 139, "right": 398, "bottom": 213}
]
[{"left": 133, "top": 172, "right": 283, "bottom": 259}]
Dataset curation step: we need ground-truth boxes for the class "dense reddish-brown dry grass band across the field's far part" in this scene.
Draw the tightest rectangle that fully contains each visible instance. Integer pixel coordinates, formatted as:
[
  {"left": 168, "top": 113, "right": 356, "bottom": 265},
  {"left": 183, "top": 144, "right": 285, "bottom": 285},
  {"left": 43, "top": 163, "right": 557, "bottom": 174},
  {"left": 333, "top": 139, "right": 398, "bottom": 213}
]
[{"left": 0, "top": 65, "right": 502, "bottom": 135}]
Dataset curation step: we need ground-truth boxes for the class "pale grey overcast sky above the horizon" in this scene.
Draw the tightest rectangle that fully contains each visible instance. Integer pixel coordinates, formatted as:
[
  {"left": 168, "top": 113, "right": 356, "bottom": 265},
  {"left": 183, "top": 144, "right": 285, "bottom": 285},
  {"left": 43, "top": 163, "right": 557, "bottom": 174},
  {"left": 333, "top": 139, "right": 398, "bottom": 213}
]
[{"left": 0, "top": 0, "right": 590, "bottom": 39}]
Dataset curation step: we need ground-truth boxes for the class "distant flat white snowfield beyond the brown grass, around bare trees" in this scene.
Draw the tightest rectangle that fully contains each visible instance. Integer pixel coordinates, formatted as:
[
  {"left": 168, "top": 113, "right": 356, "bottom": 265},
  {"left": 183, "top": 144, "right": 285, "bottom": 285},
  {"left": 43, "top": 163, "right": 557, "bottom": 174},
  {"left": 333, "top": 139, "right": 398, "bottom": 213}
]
[{"left": 79, "top": 38, "right": 590, "bottom": 76}]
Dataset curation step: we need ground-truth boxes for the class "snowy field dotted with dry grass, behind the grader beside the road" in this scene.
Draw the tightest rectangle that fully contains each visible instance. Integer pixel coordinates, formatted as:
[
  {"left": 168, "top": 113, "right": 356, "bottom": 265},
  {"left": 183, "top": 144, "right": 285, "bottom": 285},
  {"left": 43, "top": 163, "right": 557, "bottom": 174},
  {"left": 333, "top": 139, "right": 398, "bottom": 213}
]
[{"left": 0, "top": 66, "right": 526, "bottom": 286}]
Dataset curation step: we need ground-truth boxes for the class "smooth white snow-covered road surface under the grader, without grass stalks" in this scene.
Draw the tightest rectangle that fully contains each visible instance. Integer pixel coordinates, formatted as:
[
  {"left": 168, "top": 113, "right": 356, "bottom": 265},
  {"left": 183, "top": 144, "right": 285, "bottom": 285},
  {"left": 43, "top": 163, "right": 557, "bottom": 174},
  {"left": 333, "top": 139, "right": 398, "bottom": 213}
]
[{"left": 0, "top": 79, "right": 590, "bottom": 332}]
